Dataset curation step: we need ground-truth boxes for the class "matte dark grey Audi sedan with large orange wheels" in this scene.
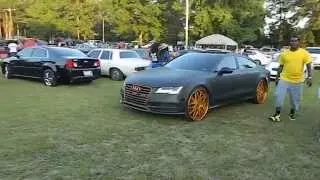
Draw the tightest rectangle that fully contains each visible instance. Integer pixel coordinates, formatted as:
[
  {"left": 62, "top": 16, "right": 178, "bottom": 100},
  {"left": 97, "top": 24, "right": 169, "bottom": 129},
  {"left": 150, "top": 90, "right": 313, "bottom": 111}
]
[{"left": 120, "top": 52, "right": 269, "bottom": 121}]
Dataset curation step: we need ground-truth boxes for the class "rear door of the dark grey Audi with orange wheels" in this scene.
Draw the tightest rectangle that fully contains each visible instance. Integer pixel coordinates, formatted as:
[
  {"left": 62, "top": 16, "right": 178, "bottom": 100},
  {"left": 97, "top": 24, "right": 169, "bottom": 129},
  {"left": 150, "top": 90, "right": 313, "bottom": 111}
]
[{"left": 236, "top": 56, "right": 259, "bottom": 97}]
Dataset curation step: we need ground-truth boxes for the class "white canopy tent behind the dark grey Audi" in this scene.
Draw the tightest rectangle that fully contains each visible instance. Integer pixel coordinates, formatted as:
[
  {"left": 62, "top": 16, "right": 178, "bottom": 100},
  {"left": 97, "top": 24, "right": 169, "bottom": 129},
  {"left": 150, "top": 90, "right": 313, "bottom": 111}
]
[{"left": 196, "top": 34, "right": 238, "bottom": 50}]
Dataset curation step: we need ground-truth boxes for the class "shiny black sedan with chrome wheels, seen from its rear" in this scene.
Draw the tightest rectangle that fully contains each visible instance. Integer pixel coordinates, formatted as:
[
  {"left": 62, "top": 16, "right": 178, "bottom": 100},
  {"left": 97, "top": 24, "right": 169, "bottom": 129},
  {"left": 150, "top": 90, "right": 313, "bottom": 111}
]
[{"left": 1, "top": 46, "right": 100, "bottom": 86}]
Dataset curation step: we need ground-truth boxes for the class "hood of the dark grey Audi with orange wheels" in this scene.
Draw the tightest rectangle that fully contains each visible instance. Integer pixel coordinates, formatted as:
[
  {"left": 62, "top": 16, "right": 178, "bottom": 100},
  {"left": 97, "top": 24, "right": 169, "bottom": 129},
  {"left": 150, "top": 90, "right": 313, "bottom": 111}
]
[{"left": 126, "top": 67, "right": 212, "bottom": 87}]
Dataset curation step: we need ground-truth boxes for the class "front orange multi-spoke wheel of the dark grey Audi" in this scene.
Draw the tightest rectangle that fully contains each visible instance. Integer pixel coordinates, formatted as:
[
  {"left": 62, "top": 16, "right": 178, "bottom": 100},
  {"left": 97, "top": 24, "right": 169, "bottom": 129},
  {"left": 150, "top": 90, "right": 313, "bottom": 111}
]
[{"left": 185, "top": 87, "right": 209, "bottom": 121}]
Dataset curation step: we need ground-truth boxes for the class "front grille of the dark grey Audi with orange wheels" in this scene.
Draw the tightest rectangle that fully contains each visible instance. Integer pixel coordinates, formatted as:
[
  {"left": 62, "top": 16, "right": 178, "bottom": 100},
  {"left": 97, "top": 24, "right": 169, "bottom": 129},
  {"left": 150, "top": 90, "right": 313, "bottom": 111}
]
[{"left": 124, "top": 84, "right": 152, "bottom": 105}]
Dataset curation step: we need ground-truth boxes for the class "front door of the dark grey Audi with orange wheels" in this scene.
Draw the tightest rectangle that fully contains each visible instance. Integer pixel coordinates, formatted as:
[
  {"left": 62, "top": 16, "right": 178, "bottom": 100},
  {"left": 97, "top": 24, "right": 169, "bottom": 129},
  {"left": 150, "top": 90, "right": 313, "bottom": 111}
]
[{"left": 211, "top": 55, "right": 239, "bottom": 103}]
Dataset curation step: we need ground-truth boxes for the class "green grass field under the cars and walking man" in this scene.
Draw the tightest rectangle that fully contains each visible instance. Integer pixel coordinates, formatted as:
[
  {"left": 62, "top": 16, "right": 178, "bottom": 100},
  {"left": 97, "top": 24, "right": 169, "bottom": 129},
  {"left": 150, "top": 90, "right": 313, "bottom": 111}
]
[{"left": 0, "top": 72, "right": 320, "bottom": 180}]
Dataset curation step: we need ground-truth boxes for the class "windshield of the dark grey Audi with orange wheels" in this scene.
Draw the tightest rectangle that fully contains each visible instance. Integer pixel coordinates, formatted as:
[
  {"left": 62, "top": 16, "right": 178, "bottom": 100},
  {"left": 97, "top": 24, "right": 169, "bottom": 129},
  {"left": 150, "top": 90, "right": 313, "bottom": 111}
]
[{"left": 166, "top": 53, "right": 223, "bottom": 72}]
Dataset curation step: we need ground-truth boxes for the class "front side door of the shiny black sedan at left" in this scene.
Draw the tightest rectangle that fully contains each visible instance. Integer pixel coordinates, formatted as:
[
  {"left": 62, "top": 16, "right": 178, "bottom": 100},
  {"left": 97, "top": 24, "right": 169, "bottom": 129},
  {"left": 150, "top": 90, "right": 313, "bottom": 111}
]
[{"left": 10, "top": 48, "right": 33, "bottom": 76}]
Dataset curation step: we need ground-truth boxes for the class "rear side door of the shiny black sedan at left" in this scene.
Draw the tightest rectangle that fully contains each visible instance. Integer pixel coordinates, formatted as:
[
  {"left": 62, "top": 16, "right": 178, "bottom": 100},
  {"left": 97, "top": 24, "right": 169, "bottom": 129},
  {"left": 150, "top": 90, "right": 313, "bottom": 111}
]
[{"left": 26, "top": 48, "right": 49, "bottom": 78}]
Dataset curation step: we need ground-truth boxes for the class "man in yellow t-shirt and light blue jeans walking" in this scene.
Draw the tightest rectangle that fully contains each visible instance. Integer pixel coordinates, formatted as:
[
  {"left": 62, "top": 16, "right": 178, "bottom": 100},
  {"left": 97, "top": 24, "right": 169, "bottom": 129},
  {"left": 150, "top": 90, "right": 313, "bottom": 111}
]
[{"left": 269, "top": 37, "right": 312, "bottom": 122}]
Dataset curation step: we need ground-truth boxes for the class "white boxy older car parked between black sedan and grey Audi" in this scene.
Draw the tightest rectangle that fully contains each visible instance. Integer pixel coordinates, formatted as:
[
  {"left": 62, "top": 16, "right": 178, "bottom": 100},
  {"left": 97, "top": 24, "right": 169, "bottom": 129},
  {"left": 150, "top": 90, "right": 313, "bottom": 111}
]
[{"left": 88, "top": 49, "right": 151, "bottom": 81}]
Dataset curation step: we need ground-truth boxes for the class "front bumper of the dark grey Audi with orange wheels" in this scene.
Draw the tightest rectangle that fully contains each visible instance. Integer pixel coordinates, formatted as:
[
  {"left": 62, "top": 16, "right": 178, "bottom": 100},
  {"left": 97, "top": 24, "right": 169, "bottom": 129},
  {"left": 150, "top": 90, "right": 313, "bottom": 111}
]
[{"left": 120, "top": 90, "right": 185, "bottom": 114}]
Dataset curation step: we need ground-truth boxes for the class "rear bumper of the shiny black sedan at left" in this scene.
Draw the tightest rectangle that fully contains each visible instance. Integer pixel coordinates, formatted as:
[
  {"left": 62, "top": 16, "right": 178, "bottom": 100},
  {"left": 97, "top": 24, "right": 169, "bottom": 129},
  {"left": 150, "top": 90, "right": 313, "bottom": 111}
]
[{"left": 62, "top": 68, "right": 101, "bottom": 82}]
